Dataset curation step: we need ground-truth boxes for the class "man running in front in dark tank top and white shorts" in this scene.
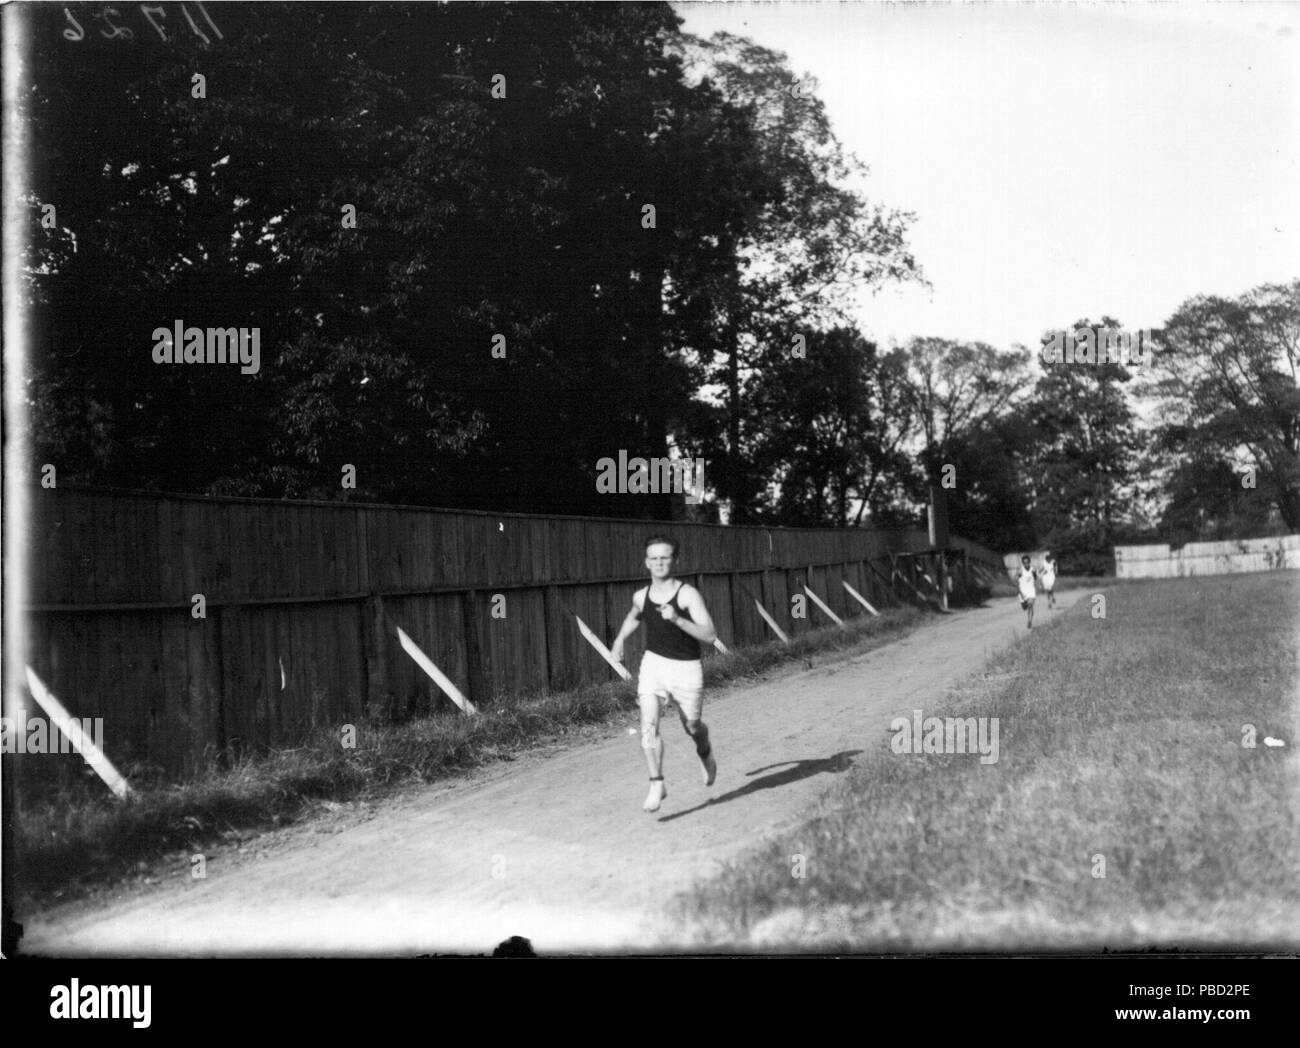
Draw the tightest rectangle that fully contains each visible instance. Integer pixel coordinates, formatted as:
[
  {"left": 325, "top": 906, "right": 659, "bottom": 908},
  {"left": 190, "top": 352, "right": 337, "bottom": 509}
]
[{"left": 610, "top": 534, "right": 718, "bottom": 811}]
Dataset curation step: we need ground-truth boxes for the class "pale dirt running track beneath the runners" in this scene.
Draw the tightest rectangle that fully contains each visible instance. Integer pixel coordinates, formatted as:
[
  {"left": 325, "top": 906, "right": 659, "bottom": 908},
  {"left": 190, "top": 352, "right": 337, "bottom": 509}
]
[{"left": 20, "top": 592, "right": 1079, "bottom": 956}]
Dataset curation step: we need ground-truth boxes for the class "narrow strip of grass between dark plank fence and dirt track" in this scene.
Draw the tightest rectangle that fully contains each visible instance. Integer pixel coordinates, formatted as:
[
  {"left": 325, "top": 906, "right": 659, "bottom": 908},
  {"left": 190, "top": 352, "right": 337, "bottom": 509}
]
[{"left": 14, "top": 595, "right": 926, "bottom": 905}]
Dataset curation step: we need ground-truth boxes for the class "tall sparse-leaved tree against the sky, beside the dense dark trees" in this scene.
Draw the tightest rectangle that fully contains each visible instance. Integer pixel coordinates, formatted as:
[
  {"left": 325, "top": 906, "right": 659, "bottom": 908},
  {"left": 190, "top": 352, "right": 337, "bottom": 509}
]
[{"left": 679, "top": 33, "right": 919, "bottom": 523}]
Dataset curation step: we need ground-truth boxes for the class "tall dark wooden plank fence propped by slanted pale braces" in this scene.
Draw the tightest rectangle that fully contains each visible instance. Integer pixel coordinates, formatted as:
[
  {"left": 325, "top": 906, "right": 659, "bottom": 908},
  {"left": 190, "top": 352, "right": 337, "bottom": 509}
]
[{"left": 17, "top": 488, "right": 1000, "bottom": 775}]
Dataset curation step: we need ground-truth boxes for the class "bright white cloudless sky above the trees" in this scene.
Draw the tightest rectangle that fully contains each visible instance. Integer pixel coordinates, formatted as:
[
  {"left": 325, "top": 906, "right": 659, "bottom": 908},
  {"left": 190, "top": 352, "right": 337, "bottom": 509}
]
[{"left": 675, "top": 0, "right": 1300, "bottom": 350}]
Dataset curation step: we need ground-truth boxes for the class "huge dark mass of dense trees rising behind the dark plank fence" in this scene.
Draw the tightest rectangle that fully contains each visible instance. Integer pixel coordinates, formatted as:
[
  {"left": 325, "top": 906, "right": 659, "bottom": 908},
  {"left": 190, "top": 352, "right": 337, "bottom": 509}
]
[{"left": 25, "top": 4, "right": 800, "bottom": 516}]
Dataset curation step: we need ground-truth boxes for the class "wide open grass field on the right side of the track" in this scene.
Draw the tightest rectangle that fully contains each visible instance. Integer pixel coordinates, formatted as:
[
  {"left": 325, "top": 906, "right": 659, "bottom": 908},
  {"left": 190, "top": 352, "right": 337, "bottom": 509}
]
[{"left": 672, "top": 572, "right": 1300, "bottom": 952}]
